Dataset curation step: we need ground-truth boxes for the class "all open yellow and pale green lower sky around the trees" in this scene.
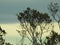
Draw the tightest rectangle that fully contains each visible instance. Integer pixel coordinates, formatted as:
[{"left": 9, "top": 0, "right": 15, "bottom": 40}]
[{"left": 0, "top": 23, "right": 60, "bottom": 44}]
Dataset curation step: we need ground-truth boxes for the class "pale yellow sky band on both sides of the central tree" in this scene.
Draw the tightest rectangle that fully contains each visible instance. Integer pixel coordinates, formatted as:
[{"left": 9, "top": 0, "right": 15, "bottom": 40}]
[{"left": 0, "top": 23, "right": 60, "bottom": 36}]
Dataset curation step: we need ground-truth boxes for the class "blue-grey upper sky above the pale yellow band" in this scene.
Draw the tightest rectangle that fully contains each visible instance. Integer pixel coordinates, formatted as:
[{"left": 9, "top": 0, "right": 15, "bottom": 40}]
[{"left": 0, "top": 0, "right": 60, "bottom": 23}]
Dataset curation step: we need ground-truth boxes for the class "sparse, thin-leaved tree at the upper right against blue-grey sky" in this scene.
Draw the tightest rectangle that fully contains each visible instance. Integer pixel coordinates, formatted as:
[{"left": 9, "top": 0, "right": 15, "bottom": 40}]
[{"left": 48, "top": 2, "right": 60, "bottom": 28}]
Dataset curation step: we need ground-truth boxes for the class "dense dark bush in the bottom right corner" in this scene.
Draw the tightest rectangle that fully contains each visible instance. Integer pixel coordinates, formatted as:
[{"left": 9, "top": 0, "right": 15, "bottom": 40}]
[{"left": 45, "top": 31, "right": 60, "bottom": 45}]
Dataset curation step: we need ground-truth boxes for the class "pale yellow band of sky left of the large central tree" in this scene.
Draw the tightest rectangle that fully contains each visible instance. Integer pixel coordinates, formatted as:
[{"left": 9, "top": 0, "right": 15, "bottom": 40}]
[{"left": 0, "top": 23, "right": 19, "bottom": 36}]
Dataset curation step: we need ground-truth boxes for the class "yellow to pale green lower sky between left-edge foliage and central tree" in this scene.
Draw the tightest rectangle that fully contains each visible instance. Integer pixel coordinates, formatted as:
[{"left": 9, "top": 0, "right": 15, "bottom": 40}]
[{"left": 0, "top": 23, "right": 20, "bottom": 44}]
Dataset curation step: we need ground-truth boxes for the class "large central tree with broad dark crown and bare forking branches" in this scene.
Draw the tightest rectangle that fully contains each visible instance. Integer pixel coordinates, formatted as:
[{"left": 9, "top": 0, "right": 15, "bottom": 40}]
[{"left": 17, "top": 7, "right": 51, "bottom": 45}]
